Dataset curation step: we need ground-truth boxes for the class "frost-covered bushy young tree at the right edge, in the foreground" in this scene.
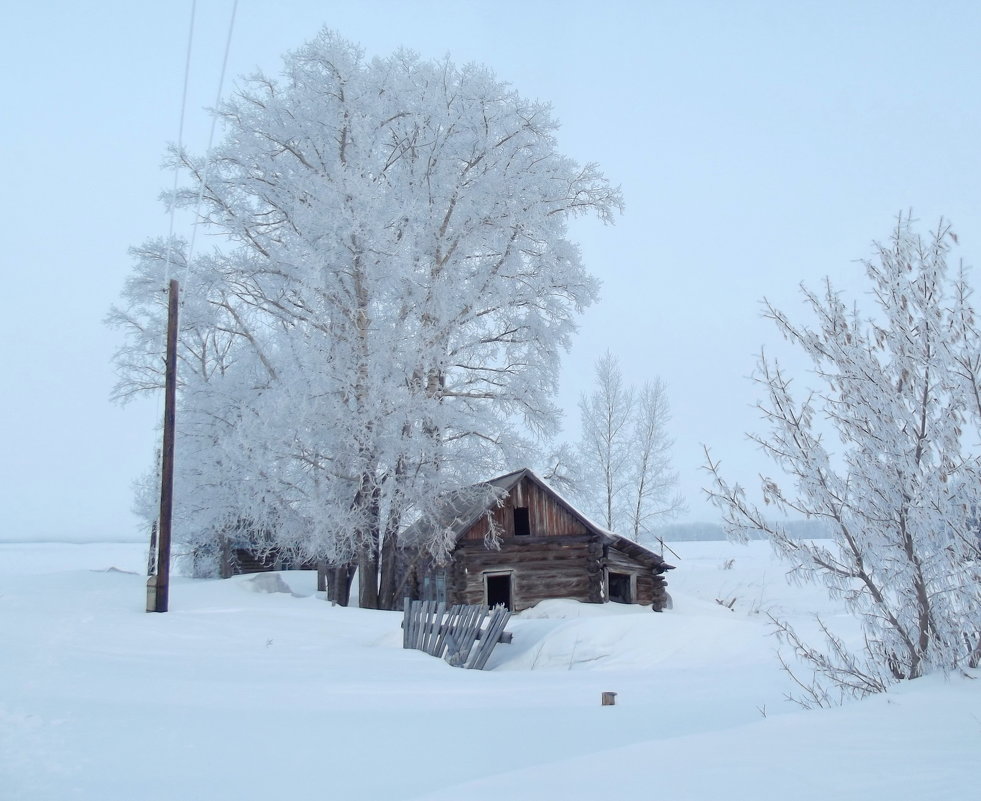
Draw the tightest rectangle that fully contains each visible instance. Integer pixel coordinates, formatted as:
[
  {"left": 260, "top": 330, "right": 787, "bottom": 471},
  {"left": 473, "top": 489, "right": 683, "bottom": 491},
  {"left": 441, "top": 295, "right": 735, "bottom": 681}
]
[{"left": 708, "top": 217, "right": 981, "bottom": 706}]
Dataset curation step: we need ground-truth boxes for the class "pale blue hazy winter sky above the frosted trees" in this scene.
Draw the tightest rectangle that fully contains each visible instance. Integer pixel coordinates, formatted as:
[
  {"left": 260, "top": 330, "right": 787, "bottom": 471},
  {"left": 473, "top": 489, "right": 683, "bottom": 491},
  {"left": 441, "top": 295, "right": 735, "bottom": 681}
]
[{"left": 0, "top": 0, "right": 981, "bottom": 539}]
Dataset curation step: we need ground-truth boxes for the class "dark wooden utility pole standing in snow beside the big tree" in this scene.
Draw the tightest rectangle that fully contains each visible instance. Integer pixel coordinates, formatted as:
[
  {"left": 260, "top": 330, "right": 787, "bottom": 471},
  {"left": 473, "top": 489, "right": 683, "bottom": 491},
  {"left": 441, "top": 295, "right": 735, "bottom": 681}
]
[{"left": 146, "top": 280, "right": 178, "bottom": 612}]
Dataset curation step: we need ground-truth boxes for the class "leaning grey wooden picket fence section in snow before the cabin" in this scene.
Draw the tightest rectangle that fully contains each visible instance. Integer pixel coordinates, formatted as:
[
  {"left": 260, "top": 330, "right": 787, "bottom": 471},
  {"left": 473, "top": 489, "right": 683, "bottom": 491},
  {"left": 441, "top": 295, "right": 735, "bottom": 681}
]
[{"left": 402, "top": 598, "right": 511, "bottom": 670}]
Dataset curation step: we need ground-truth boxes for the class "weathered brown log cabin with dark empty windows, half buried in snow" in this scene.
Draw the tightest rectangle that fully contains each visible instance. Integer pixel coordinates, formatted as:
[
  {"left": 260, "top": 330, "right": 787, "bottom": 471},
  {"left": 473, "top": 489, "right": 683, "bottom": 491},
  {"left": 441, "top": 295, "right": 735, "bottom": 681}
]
[{"left": 400, "top": 469, "right": 673, "bottom": 612}]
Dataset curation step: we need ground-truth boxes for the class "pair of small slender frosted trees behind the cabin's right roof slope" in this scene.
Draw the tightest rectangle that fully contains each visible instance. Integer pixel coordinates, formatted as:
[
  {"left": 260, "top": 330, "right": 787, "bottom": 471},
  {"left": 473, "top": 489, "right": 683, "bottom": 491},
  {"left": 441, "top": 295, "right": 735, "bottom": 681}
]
[{"left": 573, "top": 351, "right": 684, "bottom": 539}]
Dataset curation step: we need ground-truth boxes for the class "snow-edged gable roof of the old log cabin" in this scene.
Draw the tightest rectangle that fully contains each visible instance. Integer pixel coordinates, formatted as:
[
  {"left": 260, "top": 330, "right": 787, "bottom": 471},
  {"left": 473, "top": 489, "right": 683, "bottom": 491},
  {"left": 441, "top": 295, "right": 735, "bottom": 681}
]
[{"left": 405, "top": 467, "right": 674, "bottom": 570}]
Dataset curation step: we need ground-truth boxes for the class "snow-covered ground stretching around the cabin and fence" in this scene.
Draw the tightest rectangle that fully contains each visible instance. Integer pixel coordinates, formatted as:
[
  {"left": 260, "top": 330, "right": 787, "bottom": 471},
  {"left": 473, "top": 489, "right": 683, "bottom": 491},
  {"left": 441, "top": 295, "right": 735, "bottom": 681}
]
[{"left": 0, "top": 542, "right": 981, "bottom": 801}]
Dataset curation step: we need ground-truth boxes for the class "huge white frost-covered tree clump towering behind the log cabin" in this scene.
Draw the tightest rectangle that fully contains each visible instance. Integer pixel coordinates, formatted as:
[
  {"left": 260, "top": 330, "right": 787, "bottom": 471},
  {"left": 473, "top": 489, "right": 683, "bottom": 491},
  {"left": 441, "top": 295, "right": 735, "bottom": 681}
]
[{"left": 111, "top": 31, "right": 622, "bottom": 606}]
